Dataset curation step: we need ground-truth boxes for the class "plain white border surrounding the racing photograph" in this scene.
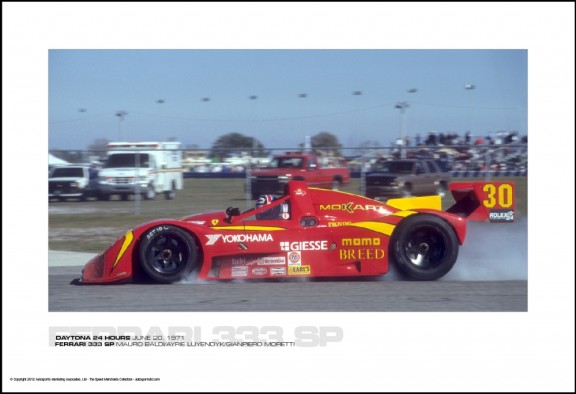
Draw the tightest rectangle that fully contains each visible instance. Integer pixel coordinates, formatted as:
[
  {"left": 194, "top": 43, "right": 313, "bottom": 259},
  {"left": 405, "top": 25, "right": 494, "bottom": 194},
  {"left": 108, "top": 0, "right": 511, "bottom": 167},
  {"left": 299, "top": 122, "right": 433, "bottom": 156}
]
[{"left": 2, "top": 2, "right": 574, "bottom": 391}]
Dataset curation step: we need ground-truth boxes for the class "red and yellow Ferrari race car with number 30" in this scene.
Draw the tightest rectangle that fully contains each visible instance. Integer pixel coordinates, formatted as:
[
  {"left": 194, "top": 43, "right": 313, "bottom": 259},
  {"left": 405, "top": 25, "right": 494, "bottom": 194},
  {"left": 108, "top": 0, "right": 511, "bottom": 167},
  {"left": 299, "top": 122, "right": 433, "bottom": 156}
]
[{"left": 80, "top": 181, "right": 515, "bottom": 284}]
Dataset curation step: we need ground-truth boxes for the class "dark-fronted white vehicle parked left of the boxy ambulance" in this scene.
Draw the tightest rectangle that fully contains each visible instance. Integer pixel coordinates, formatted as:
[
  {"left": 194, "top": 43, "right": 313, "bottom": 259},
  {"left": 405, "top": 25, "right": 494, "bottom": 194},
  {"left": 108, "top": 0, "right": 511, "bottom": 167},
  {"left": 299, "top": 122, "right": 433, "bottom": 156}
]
[{"left": 48, "top": 165, "right": 98, "bottom": 201}]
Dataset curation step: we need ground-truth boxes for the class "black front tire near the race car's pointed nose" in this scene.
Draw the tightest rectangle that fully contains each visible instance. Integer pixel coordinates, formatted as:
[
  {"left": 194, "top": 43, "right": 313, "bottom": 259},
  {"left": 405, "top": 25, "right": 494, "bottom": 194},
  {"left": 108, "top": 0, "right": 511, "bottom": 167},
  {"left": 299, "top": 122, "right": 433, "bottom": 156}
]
[{"left": 139, "top": 225, "right": 199, "bottom": 283}]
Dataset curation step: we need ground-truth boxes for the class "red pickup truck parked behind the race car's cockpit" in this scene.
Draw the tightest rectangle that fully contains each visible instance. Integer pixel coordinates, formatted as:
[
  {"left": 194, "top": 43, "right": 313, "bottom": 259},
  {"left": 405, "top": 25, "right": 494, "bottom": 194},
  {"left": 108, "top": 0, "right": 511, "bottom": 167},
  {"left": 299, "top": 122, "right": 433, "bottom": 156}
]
[{"left": 250, "top": 152, "right": 350, "bottom": 200}]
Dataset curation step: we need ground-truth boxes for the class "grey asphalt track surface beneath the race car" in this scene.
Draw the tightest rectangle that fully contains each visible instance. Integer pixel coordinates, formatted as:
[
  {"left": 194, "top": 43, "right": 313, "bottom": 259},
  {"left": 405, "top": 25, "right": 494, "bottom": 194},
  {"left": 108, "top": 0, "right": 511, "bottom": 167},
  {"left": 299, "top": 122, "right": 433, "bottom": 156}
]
[{"left": 49, "top": 252, "right": 528, "bottom": 312}]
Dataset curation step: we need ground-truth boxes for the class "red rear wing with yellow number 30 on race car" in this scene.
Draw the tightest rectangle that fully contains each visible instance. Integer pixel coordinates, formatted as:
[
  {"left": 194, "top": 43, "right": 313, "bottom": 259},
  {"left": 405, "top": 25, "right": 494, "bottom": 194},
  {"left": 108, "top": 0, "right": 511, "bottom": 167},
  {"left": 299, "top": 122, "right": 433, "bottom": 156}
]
[{"left": 446, "top": 181, "right": 516, "bottom": 223}]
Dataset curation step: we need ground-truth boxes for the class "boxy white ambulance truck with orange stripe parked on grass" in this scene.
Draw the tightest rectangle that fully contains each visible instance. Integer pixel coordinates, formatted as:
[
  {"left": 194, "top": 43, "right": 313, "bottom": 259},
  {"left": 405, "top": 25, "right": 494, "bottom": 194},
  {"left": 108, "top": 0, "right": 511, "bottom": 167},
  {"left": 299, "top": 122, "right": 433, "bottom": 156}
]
[{"left": 98, "top": 142, "right": 184, "bottom": 200}]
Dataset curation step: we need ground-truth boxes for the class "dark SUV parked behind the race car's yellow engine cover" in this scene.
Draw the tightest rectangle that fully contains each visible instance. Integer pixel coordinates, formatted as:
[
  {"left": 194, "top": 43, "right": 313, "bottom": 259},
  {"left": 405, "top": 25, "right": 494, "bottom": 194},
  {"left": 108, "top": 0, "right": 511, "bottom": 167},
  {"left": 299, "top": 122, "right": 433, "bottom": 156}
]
[{"left": 365, "top": 159, "right": 451, "bottom": 199}]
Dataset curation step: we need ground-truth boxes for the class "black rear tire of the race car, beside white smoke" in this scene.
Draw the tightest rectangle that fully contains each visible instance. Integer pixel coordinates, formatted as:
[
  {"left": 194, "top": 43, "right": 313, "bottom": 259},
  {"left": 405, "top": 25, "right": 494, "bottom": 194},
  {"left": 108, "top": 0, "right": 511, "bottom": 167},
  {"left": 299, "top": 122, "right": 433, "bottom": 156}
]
[{"left": 389, "top": 214, "right": 459, "bottom": 280}]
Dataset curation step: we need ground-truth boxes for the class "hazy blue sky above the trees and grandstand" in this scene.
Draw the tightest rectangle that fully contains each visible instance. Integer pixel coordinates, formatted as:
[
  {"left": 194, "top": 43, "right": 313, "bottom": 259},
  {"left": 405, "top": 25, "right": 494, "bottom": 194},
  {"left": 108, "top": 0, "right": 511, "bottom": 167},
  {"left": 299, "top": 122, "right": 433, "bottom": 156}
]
[{"left": 49, "top": 49, "right": 528, "bottom": 149}]
